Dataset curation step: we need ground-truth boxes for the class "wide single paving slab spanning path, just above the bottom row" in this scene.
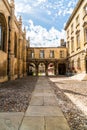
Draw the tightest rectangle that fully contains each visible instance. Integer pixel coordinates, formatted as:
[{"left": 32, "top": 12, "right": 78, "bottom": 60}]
[{"left": 25, "top": 106, "right": 64, "bottom": 117}]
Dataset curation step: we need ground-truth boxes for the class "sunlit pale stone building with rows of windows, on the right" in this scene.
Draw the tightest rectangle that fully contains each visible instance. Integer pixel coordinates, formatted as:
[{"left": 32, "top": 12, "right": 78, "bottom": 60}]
[{"left": 65, "top": 0, "right": 87, "bottom": 78}]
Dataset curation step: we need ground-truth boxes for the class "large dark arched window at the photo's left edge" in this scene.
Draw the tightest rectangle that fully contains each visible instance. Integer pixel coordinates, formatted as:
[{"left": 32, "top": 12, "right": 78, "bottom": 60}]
[{"left": 0, "top": 13, "right": 7, "bottom": 51}]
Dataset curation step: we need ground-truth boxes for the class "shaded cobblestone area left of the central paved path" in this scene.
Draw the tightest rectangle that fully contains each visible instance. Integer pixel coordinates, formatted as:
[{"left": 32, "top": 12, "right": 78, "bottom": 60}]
[{"left": 0, "top": 77, "right": 37, "bottom": 112}]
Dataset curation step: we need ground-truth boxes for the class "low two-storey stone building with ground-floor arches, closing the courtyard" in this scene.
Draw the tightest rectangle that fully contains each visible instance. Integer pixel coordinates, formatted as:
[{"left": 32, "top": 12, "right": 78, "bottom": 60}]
[{"left": 27, "top": 40, "right": 67, "bottom": 76}]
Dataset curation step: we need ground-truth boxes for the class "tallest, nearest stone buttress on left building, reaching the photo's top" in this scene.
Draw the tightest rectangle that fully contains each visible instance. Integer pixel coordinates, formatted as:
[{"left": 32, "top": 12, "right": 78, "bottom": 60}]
[{"left": 8, "top": 0, "right": 15, "bottom": 80}]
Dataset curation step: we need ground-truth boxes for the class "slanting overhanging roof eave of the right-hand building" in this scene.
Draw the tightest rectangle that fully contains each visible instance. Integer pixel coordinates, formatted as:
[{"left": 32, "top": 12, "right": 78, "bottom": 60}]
[{"left": 64, "top": 0, "right": 84, "bottom": 30}]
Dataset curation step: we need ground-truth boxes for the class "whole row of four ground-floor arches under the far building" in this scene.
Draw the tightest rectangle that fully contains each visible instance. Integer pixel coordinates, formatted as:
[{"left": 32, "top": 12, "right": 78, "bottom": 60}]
[{"left": 27, "top": 60, "right": 66, "bottom": 76}]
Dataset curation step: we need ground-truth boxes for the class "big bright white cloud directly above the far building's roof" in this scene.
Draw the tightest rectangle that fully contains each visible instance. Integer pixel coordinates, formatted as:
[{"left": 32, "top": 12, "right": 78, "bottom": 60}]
[{"left": 27, "top": 20, "right": 65, "bottom": 47}]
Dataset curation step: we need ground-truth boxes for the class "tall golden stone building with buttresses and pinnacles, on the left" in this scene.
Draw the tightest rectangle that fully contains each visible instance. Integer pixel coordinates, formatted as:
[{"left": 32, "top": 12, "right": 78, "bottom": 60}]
[{"left": 0, "top": 0, "right": 26, "bottom": 82}]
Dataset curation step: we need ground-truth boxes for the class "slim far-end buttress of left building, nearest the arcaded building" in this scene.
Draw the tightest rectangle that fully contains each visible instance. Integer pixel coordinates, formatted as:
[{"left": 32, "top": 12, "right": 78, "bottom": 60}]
[{"left": 23, "top": 28, "right": 26, "bottom": 76}]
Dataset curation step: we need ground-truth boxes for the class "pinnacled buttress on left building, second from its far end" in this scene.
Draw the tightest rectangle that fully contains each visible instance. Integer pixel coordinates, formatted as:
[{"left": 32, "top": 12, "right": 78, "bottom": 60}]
[{"left": 18, "top": 16, "right": 23, "bottom": 78}]
